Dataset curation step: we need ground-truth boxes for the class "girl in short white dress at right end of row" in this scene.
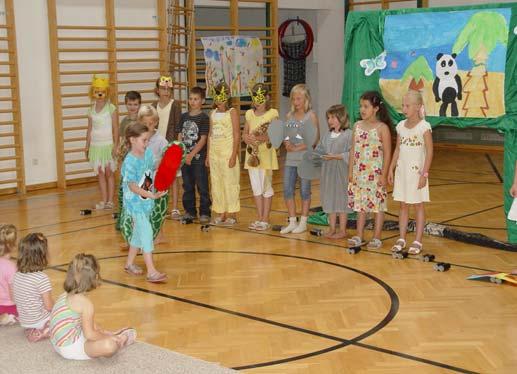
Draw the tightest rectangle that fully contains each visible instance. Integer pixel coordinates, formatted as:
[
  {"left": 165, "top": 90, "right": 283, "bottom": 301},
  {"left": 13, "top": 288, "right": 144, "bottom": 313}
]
[{"left": 388, "top": 90, "right": 433, "bottom": 254}]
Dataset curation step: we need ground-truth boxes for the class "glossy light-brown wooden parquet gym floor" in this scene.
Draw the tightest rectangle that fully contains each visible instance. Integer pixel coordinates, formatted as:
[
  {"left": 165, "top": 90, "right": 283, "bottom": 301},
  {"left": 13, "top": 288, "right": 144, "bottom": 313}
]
[{"left": 0, "top": 151, "right": 517, "bottom": 373}]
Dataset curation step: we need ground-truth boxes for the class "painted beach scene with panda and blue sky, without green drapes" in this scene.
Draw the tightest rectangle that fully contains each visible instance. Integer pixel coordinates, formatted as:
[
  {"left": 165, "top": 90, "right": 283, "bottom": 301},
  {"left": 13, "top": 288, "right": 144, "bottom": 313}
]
[{"left": 371, "top": 8, "right": 511, "bottom": 118}]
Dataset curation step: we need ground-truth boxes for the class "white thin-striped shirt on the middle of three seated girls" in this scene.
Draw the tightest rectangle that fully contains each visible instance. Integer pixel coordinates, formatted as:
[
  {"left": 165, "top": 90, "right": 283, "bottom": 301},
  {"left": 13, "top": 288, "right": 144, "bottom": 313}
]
[{"left": 13, "top": 271, "right": 52, "bottom": 327}]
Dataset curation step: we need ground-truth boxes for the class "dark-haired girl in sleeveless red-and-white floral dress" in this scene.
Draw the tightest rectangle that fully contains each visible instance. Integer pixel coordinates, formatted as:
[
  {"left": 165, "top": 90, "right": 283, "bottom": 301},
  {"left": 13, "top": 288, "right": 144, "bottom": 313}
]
[{"left": 348, "top": 91, "right": 392, "bottom": 249}]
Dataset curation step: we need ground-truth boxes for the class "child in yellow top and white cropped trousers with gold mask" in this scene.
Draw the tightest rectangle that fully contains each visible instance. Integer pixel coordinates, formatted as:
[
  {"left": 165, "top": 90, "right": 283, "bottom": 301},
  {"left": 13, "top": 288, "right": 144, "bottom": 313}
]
[{"left": 242, "top": 83, "right": 278, "bottom": 231}]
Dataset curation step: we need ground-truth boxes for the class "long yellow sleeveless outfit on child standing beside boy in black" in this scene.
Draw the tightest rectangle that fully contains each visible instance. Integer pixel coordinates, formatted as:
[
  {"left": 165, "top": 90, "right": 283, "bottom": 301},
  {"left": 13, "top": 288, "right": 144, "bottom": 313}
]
[{"left": 208, "top": 108, "right": 241, "bottom": 214}]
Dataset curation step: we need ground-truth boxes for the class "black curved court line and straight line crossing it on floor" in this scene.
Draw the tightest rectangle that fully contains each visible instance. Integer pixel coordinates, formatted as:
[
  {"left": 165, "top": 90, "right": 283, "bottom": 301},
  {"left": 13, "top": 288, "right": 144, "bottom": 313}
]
[{"left": 50, "top": 250, "right": 476, "bottom": 373}]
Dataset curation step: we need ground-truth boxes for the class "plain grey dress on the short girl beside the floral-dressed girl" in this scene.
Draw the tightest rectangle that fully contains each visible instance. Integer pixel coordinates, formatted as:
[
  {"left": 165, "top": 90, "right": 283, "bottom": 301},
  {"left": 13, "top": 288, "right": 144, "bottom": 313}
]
[{"left": 317, "top": 129, "right": 352, "bottom": 213}]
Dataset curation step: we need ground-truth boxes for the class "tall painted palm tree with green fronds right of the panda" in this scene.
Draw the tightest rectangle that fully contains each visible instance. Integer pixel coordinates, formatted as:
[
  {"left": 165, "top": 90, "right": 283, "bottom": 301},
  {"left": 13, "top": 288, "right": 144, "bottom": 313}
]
[{"left": 452, "top": 11, "right": 508, "bottom": 117}]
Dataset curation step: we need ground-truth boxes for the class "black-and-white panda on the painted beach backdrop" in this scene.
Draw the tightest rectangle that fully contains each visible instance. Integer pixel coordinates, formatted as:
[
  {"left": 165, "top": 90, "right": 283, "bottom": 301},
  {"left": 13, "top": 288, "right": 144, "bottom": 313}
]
[{"left": 433, "top": 53, "right": 462, "bottom": 117}]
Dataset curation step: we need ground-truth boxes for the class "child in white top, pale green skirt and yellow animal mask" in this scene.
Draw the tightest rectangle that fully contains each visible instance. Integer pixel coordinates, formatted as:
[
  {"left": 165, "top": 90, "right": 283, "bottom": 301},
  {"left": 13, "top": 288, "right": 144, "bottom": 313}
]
[{"left": 86, "top": 75, "right": 119, "bottom": 209}]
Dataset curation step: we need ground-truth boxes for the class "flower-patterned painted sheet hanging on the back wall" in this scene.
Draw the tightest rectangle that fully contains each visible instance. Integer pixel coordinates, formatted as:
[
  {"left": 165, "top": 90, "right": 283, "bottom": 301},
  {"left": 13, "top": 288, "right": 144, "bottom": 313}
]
[{"left": 201, "top": 36, "right": 264, "bottom": 97}]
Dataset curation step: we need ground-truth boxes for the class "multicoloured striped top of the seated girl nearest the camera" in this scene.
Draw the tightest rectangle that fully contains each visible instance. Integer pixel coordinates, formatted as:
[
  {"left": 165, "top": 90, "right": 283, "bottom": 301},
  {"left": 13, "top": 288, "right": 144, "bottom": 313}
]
[{"left": 50, "top": 293, "right": 82, "bottom": 347}]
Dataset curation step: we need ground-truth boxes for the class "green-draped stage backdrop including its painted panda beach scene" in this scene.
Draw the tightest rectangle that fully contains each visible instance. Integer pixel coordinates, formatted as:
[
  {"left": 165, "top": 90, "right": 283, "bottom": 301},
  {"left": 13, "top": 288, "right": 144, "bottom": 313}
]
[{"left": 342, "top": 3, "right": 517, "bottom": 243}]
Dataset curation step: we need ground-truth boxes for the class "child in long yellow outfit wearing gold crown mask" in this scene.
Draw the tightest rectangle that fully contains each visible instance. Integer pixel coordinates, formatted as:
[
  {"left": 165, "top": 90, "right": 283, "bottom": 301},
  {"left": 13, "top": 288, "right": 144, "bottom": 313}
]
[{"left": 206, "top": 82, "right": 241, "bottom": 226}]
